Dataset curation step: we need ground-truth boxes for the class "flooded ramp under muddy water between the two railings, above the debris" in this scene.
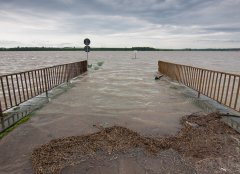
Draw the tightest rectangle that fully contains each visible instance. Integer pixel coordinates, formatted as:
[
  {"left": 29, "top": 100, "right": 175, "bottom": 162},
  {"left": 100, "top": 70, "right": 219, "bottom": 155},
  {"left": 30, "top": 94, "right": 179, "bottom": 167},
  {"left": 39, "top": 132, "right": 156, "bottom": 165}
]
[{"left": 0, "top": 59, "right": 201, "bottom": 174}]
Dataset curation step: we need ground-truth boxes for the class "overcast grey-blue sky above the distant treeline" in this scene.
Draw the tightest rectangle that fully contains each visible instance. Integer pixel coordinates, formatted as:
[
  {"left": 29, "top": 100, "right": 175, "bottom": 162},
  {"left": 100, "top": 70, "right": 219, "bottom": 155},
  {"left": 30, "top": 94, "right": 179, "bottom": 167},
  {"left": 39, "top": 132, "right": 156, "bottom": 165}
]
[{"left": 0, "top": 0, "right": 240, "bottom": 48}]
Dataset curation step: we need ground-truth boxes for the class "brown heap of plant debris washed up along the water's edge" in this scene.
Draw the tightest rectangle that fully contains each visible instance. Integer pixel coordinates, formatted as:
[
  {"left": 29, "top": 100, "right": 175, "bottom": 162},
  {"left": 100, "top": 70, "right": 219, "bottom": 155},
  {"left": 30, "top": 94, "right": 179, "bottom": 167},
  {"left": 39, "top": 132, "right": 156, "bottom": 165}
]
[{"left": 32, "top": 113, "right": 240, "bottom": 174}]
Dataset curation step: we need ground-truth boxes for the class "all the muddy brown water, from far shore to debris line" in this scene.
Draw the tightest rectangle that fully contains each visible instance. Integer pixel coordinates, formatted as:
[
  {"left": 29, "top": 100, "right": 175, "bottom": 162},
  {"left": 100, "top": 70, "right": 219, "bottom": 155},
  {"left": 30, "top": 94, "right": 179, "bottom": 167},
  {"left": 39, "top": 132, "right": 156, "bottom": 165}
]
[{"left": 0, "top": 52, "right": 240, "bottom": 174}]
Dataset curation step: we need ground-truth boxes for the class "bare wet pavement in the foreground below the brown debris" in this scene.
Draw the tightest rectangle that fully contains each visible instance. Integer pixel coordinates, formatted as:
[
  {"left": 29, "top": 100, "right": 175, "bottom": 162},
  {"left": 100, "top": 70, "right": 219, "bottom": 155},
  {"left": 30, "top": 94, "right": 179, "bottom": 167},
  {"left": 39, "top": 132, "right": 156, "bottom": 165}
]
[{"left": 61, "top": 149, "right": 196, "bottom": 174}]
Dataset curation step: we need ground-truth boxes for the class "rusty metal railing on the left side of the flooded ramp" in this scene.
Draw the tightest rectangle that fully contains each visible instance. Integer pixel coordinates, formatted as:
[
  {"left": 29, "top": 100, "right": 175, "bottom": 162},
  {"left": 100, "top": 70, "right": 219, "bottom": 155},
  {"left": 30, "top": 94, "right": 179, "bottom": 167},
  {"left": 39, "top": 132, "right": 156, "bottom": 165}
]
[{"left": 0, "top": 61, "right": 87, "bottom": 118}]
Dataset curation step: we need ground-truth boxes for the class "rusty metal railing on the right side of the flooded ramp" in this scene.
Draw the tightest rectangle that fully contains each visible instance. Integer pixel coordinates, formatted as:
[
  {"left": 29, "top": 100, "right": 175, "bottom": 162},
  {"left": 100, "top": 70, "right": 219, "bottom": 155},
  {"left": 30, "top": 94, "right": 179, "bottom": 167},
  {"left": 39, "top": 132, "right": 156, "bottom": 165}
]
[{"left": 158, "top": 61, "right": 240, "bottom": 112}]
